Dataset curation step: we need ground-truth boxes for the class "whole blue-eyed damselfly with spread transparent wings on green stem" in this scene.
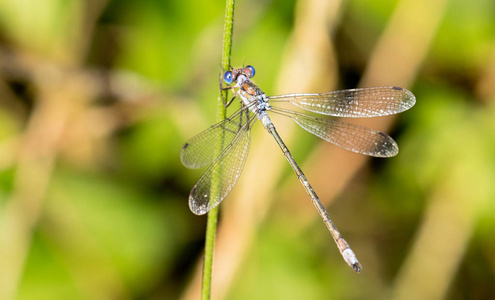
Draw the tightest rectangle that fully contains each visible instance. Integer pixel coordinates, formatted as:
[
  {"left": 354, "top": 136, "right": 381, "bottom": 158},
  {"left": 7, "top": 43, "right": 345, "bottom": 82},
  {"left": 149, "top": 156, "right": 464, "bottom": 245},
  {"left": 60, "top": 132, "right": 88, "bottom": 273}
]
[{"left": 180, "top": 65, "right": 416, "bottom": 273}]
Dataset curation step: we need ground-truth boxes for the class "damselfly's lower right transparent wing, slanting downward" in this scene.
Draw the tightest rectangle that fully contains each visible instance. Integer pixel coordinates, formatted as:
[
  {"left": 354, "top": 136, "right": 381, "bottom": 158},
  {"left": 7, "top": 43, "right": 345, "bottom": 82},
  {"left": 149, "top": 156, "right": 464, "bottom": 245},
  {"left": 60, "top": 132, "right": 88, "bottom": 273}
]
[{"left": 272, "top": 107, "right": 399, "bottom": 157}]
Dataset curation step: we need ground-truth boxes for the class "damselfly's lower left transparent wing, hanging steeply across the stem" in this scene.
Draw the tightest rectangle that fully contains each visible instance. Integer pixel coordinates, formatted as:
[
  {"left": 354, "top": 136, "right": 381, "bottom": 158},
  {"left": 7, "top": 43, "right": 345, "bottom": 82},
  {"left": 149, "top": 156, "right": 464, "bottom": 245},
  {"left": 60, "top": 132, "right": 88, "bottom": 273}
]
[{"left": 189, "top": 124, "right": 251, "bottom": 215}]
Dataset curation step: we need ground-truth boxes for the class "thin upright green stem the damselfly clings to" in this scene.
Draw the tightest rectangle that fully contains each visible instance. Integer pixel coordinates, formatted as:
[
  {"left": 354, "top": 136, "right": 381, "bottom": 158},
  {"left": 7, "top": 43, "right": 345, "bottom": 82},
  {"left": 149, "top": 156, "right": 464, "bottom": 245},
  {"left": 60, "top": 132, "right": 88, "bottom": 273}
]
[{"left": 201, "top": 0, "right": 235, "bottom": 300}]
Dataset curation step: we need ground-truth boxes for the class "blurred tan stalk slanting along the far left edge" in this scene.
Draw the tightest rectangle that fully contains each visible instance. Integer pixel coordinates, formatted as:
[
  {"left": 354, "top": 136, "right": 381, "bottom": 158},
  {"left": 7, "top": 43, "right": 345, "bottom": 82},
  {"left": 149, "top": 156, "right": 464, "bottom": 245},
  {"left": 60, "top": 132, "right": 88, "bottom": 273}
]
[{"left": 0, "top": 69, "right": 68, "bottom": 299}]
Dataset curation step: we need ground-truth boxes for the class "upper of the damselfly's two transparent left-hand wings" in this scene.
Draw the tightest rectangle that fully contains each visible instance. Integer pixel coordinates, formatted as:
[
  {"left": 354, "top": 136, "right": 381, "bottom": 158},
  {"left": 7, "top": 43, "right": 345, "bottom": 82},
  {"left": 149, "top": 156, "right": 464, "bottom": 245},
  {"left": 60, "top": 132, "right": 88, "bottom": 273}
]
[{"left": 180, "top": 108, "right": 253, "bottom": 169}]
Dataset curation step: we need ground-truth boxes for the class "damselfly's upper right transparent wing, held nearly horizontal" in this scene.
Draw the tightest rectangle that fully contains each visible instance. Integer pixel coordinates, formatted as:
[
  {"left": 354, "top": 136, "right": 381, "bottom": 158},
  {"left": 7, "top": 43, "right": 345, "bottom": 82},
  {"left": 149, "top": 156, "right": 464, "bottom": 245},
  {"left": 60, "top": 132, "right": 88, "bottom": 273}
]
[{"left": 268, "top": 87, "right": 416, "bottom": 118}]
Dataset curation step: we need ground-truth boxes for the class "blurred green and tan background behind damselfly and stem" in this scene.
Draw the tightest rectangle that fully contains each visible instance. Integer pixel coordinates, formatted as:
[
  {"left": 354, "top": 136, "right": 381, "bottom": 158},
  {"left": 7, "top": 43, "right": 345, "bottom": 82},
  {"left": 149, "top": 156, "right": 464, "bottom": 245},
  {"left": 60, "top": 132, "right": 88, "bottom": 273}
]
[{"left": 0, "top": 0, "right": 495, "bottom": 299}]
